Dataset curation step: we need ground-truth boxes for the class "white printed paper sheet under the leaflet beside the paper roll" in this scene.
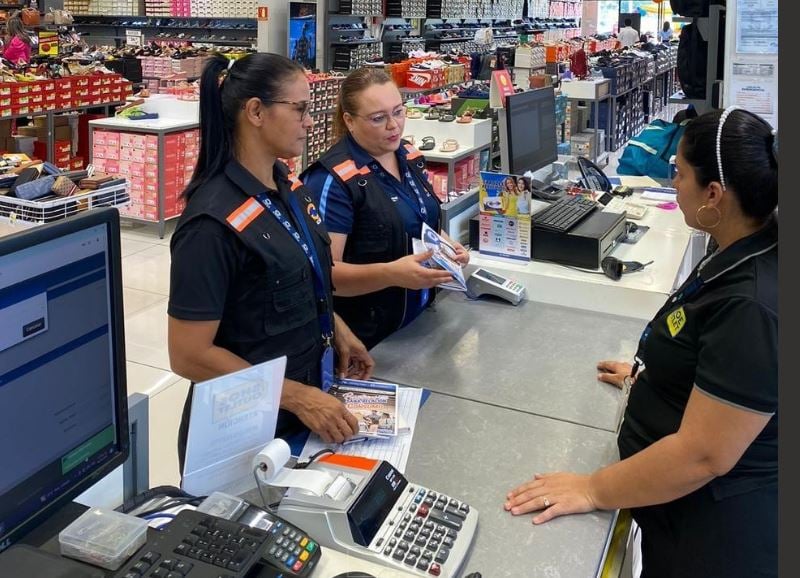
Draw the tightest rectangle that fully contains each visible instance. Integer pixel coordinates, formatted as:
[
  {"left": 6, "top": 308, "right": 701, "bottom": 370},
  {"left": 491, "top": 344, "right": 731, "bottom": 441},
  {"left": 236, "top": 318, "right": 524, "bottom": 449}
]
[{"left": 298, "top": 387, "right": 422, "bottom": 472}]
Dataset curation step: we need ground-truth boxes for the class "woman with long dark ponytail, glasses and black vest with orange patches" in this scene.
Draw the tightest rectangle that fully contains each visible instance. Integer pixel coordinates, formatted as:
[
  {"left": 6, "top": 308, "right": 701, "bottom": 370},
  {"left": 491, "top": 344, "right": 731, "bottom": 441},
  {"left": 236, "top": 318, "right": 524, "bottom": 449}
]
[{"left": 168, "top": 53, "right": 373, "bottom": 467}]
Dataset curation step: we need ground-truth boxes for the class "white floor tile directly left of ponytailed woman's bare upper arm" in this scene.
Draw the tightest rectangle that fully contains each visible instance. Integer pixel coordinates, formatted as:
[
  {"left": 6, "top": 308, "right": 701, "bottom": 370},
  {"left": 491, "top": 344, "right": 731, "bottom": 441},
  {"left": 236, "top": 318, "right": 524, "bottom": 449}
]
[{"left": 125, "top": 297, "right": 170, "bottom": 371}]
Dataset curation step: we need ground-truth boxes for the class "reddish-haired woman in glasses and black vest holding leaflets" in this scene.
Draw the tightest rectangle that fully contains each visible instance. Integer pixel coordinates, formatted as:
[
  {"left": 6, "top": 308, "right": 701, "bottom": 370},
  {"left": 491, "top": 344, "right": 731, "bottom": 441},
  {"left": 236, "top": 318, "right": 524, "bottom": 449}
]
[{"left": 302, "top": 68, "right": 469, "bottom": 348}]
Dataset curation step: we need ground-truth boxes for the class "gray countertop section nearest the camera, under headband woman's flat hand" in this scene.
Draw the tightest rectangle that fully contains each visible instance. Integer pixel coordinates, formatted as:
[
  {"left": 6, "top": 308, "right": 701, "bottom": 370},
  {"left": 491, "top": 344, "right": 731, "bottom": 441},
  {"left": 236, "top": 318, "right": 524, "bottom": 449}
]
[{"left": 406, "top": 393, "right": 618, "bottom": 578}]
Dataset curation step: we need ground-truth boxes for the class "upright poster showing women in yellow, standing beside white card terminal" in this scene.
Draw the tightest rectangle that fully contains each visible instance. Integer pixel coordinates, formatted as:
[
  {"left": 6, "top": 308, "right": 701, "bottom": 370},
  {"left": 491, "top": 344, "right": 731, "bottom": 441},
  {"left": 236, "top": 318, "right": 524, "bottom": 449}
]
[{"left": 478, "top": 171, "right": 531, "bottom": 261}]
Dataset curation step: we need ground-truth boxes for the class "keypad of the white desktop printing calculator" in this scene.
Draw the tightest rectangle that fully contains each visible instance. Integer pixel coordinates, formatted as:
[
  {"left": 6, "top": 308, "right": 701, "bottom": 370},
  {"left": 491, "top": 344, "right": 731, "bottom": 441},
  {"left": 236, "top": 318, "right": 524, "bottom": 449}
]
[{"left": 375, "top": 485, "right": 469, "bottom": 576}]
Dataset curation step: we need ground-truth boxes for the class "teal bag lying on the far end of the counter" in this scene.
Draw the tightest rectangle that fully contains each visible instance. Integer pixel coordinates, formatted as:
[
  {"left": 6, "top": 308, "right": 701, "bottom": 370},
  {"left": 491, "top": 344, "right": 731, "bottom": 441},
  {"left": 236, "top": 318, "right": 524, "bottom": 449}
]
[{"left": 617, "top": 120, "right": 688, "bottom": 179}]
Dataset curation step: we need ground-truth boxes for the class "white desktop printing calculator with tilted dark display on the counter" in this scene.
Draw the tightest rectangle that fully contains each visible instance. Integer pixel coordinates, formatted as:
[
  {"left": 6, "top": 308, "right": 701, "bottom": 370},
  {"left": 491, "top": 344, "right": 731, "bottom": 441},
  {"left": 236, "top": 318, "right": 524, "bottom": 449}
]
[{"left": 278, "top": 454, "right": 478, "bottom": 578}]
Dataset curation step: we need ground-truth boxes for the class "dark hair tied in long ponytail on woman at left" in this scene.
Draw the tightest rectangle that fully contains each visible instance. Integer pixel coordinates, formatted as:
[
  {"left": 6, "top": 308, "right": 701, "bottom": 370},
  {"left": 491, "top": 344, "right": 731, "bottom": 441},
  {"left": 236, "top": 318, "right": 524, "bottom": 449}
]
[{"left": 183, "top": 52, "right": 303, "bottom": 199}]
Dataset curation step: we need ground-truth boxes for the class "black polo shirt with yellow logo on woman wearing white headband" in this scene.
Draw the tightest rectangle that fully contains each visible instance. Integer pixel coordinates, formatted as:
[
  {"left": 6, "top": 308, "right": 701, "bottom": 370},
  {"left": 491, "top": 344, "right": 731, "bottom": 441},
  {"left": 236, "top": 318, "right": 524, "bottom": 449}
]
[{"left": 618, "top": 218, "right": 778, "bottom": 499}]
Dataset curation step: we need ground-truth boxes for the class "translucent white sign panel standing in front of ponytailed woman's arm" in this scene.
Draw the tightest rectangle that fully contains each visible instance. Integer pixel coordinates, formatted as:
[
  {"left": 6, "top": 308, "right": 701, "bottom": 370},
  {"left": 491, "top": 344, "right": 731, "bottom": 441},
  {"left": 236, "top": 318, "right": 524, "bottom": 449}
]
[{"left": 181, "top": 356, "right": 286, "bottom": 496}]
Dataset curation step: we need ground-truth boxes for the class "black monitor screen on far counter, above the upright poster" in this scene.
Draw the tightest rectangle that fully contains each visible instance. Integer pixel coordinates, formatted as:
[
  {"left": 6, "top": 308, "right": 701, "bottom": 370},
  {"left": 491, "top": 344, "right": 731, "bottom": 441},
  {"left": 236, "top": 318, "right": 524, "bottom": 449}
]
[{"left": 503, "top": 87, "right": 558, "bottom": 175}]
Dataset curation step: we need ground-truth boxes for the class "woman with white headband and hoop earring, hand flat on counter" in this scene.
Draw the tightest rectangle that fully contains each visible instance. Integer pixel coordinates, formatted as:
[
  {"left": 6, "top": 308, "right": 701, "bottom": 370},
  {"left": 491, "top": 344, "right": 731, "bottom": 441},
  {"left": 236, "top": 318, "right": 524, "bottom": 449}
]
[{"left": 505, "top": 107, "right": 778, "bottom": 578}]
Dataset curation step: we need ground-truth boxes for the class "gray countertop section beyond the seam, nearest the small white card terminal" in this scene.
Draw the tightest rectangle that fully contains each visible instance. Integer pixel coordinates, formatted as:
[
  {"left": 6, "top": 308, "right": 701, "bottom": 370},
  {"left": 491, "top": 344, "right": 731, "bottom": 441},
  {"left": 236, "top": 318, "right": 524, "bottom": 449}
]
[{"left": 370, "top": 293, "right": 644, "bottom": 431}]
